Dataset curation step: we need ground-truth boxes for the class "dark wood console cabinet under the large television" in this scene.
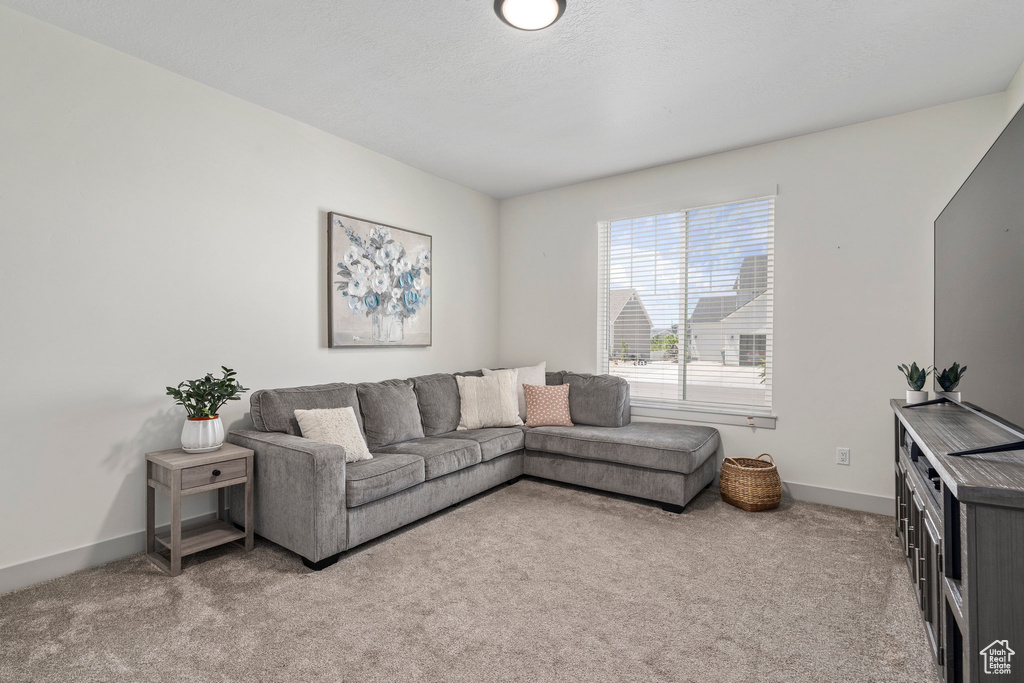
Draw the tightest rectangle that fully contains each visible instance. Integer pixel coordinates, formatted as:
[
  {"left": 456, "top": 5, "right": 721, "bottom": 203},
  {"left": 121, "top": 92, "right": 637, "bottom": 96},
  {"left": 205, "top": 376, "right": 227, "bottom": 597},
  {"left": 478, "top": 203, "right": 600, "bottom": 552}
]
[{"left": 890, "top": 399, "right": 1024, "bottom": 683}]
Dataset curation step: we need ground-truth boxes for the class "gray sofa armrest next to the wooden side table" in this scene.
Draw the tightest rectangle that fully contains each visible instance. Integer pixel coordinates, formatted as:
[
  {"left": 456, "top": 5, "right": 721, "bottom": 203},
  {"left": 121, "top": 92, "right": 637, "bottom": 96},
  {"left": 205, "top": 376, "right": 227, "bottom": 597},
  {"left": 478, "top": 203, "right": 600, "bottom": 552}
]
[{"left": 226, "top": 430, "right": 348, "bottom": 562}]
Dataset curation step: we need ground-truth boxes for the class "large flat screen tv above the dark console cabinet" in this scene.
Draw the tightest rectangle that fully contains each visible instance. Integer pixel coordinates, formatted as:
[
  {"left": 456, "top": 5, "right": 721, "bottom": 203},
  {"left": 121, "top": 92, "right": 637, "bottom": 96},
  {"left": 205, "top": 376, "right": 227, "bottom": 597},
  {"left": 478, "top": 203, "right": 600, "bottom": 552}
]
[{"left": 934, "top": 103, "right": 1024, "bottom": 429}]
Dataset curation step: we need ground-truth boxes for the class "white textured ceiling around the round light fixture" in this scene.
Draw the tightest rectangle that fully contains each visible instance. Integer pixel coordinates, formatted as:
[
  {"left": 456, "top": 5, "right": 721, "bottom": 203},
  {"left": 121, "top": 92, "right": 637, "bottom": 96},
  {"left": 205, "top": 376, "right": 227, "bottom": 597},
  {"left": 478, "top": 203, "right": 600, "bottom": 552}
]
[{"left": 6, "top": 0, "right": 1024, "bottom": 198}]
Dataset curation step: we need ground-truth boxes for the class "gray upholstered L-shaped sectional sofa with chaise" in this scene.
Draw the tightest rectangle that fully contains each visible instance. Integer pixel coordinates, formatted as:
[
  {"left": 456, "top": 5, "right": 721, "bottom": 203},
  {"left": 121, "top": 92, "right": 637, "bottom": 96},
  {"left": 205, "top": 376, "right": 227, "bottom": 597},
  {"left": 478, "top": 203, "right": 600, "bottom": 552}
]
[{"left": 227, "top": 371, "right": 719, "bottom": 569}]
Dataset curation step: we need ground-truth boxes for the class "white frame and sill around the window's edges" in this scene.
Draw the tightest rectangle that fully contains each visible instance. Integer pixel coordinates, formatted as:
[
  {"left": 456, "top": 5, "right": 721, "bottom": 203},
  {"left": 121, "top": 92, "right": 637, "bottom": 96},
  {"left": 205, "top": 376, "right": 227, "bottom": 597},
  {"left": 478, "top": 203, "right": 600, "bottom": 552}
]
[{"left": 597, "top": 185, "right": 778, "bottom": 429}]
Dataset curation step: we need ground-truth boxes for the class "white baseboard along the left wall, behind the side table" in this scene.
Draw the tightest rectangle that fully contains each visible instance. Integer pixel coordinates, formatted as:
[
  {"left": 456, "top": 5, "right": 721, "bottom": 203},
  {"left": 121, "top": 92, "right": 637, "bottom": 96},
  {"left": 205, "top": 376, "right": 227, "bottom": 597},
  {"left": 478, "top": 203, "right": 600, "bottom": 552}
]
[{"left": 0, "top": 512, "right": 216, "bottom": 595}]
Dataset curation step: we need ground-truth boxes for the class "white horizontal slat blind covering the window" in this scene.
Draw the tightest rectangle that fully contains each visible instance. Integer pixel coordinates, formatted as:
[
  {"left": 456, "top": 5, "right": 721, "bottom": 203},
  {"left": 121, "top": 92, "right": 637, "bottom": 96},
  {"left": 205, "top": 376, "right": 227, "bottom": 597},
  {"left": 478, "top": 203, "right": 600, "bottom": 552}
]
[{"left": 597, "top": 197, "right": 775, "bottom": 415}]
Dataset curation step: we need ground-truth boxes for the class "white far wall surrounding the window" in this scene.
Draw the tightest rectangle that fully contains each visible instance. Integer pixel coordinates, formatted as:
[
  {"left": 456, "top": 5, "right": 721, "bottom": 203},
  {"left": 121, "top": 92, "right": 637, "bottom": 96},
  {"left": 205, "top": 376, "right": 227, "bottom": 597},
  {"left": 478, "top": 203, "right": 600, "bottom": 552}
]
[{"left": 500, "top": 94, "right": 1007, "bottom": 505}]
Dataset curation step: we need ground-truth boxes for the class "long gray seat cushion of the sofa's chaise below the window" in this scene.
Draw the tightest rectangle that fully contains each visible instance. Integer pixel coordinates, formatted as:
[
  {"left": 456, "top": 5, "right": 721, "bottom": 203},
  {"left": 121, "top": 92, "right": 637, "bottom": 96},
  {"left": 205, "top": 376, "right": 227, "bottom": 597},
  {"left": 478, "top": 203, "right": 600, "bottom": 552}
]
[{"left": 526, "top": 421, "right": 719, "bottom": 474}]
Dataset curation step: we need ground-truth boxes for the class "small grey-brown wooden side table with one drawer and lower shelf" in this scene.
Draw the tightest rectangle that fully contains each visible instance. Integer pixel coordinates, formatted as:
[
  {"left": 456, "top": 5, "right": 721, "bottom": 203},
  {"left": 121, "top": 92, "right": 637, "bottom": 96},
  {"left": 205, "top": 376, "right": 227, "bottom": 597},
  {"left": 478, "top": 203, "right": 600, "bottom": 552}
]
[{"left": 145, "top": 443, "right": 253, "bottom": 577}]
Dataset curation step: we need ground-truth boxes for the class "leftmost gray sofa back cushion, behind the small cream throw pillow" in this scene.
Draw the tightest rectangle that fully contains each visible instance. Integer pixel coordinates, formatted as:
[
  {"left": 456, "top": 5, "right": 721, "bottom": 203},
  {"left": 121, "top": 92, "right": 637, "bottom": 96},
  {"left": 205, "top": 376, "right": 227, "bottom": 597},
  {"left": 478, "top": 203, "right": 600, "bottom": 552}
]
[{"left": 249, "top": 382, "right": 364, "bottom": 436}]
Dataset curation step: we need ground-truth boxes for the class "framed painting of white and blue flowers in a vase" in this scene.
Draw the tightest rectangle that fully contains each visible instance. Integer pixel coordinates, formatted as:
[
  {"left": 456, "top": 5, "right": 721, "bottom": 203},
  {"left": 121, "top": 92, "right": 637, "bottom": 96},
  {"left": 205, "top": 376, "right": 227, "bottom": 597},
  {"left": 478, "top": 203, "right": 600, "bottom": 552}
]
[{"left": 328, "top": 212, "right": 431, "bottom": 348}]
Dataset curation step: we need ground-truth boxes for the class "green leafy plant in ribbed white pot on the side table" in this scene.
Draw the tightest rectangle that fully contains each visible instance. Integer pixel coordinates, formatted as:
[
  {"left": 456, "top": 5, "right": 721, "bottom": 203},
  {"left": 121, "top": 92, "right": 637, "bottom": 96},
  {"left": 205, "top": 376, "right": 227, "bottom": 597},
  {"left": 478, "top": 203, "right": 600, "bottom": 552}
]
[{"left": 167, "top": 366, "right": 249, "bottom": 453}]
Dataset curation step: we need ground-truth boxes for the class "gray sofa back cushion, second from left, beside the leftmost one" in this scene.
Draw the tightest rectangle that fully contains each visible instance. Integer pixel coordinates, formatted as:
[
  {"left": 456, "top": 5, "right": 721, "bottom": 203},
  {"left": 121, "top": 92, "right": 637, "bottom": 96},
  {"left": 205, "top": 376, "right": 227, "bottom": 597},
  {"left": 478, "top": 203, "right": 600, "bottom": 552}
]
[{"left": 355, "top": 380, "right": 423, "bottom": 453}]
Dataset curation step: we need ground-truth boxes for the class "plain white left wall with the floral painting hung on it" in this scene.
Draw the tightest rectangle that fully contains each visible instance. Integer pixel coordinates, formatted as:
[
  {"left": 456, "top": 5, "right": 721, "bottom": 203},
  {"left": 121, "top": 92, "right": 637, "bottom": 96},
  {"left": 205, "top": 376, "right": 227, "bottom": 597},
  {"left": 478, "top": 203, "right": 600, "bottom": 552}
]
[{"left": 0, "top": 7, "right": 498, "bottom": 577}]
